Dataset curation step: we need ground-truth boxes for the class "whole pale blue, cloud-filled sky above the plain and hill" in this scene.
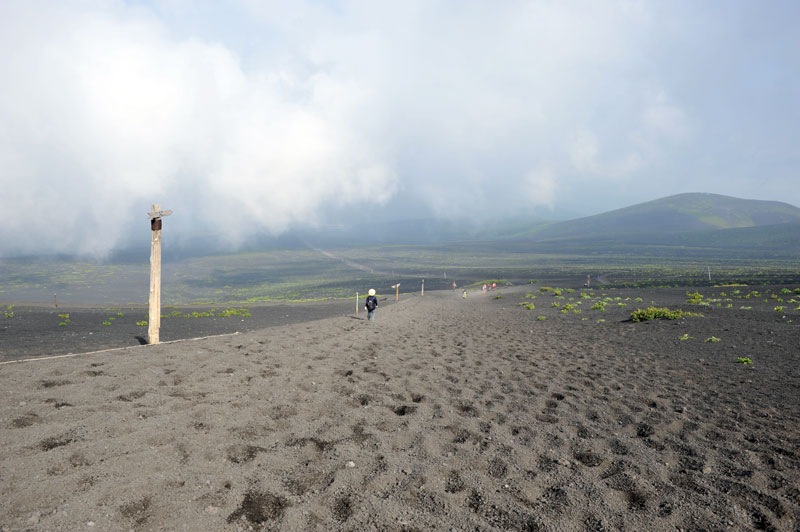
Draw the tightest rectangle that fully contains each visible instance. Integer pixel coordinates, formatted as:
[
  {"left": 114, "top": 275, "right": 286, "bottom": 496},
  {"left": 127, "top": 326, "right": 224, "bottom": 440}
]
[{"left": 0, "top": 0, "right": 800, "bottom": 256}]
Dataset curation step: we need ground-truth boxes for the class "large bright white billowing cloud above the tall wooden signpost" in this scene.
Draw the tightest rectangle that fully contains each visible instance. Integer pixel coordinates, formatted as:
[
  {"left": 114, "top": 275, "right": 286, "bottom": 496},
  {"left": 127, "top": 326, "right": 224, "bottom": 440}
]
[{"left": 0, "top": 3, "right": 395, "bottom": 254}]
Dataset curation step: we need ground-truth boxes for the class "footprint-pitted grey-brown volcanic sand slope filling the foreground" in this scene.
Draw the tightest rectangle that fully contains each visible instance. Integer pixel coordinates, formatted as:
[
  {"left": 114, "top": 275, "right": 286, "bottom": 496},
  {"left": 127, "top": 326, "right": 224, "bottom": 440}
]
[{"left": 0, "top": 287, "right": 800, "bottom": 532}]
